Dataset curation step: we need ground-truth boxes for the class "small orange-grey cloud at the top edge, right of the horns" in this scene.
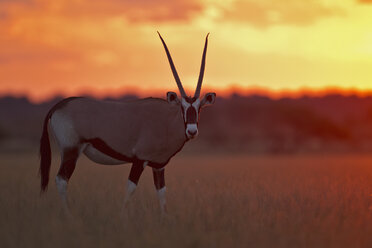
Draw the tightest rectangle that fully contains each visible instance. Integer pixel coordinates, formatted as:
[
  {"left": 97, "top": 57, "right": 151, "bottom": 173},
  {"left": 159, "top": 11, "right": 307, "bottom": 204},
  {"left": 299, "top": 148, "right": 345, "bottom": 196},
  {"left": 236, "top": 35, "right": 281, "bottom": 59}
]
[{"left": 223, "top": 0, "right": 343, "bottom": 27}]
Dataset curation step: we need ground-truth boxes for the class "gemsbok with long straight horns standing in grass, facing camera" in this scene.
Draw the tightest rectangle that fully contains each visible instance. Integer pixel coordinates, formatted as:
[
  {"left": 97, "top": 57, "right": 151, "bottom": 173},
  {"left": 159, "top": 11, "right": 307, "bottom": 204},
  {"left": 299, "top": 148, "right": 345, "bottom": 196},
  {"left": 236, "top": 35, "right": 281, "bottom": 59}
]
[{"left": 40, "top": 32, "right": 216, "bottom": 213}]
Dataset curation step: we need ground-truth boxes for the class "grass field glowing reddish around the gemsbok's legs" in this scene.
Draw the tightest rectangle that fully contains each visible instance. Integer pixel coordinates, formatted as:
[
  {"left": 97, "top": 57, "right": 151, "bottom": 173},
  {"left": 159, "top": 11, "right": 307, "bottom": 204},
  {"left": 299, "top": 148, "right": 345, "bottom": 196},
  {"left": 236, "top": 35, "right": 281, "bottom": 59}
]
[{"left": 0, "top": 154, "right": 372, "bottom": 247}]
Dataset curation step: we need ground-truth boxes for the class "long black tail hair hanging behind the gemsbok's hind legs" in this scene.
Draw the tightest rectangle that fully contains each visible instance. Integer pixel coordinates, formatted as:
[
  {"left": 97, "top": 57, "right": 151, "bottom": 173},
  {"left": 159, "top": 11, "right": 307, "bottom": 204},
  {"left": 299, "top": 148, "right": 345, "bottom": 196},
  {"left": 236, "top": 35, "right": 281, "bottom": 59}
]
[{"left": 39, "top": 113, "right": 52, "bottom": 192}]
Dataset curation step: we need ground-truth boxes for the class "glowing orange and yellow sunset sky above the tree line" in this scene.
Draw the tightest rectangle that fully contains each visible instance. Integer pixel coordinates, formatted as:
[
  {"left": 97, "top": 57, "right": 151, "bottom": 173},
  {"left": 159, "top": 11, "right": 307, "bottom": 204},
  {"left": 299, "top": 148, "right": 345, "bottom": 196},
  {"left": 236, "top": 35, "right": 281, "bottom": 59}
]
[{"left": 0, "top": 0, "right": 372, "bottom": 101}]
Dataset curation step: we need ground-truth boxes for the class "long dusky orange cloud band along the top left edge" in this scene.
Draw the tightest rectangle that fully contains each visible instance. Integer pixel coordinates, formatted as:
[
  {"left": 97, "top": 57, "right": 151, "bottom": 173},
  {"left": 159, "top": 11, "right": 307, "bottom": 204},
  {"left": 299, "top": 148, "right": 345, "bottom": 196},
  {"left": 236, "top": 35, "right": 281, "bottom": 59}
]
[{"left": 0, "top": 0, "right": 204, "bottom": 23}]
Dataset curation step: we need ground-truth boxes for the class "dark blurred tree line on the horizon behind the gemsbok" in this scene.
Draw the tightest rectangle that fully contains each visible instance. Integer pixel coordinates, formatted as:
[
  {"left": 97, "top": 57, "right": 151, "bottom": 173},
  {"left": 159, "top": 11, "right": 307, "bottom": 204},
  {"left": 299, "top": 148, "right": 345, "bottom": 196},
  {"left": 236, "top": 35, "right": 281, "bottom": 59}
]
[{"left": 0, "top": 94, "right": 372, "bottom": 153}]
